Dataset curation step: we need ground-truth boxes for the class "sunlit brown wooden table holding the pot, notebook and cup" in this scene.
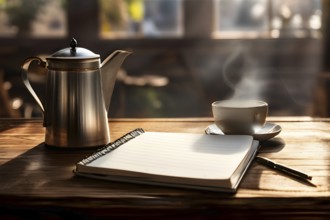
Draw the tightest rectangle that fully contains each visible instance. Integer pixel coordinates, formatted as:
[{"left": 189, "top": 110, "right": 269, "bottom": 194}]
[{"left": 0, "top": 117, "right": 330, "bottom": 219}]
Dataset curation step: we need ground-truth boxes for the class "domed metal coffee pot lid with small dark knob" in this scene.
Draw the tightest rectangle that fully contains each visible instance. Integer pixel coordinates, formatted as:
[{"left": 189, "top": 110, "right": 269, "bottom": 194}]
[{"left": 48, "top": 38, "right": 100, "bottom": 59}]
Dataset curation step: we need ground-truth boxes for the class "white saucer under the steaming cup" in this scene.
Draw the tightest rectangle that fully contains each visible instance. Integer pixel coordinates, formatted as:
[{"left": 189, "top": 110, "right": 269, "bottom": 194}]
[{"left": 205, "top": 122, "right": 282, "bottom": 141}]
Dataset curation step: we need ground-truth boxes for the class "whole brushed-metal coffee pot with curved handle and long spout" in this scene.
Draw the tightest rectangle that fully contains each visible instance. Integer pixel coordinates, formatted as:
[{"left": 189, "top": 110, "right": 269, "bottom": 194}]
[{"left": 22, "top": 39, "right": 130, "bottom": 148}]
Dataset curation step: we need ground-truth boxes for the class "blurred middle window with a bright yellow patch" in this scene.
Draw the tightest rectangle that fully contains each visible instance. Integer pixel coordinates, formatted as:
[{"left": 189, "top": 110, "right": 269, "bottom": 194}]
[{"left": 100, "top": 0, "right": 183, "bottom": 38}]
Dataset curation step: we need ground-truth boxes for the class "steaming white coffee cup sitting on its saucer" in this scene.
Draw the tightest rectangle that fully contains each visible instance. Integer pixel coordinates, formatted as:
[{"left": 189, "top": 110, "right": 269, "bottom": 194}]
[{"left": 212, "top": 100, "right": 268, "bottom": 135}]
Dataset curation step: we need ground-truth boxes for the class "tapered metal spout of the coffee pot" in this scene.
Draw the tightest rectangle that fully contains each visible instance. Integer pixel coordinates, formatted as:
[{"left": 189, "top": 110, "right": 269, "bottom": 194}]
[{"left": 101, "top": 50, "right": 131, "bottom": 111}]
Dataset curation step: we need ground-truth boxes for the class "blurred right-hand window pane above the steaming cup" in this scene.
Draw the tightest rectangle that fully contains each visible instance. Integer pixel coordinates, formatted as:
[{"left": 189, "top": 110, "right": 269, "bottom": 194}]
[{"left": 213, "top": 0, "right": 322, "bottom": 38}]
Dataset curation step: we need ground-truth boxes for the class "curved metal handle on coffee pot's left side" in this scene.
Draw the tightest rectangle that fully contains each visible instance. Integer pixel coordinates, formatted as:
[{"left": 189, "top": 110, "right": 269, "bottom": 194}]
[{"left": 21, "top": 57, "right": 46, "bottom": 114}]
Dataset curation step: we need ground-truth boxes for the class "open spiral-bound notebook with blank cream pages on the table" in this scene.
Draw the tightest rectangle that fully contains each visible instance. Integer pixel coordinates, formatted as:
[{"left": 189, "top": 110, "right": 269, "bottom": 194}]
[{"left": 74, "top": 129, "right": 258, "bottom": 192}]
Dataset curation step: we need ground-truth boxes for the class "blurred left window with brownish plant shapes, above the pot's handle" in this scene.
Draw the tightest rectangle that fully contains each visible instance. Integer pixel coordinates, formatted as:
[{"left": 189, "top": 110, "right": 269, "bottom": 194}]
[{"left": 0, "top": 0, "right": 67, "bottom": 37}]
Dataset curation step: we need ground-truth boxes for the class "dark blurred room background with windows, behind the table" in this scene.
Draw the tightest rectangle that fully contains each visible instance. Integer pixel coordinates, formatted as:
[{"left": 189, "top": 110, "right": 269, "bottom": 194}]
[{"left": 0, "top": 0, "right": 330, "bottom": 118}]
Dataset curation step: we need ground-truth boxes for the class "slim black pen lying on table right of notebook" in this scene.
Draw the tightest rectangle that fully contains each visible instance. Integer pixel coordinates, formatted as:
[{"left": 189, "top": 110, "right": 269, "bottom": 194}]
[{"left": 256, "top": 156, "right": 312, "bottom": 181}]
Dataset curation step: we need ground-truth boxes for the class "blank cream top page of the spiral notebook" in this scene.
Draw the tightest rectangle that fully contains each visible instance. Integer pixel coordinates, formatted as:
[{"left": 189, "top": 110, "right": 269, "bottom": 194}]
[{"left": 87, "top": 132, "right": 253, "bottom": 179}]
